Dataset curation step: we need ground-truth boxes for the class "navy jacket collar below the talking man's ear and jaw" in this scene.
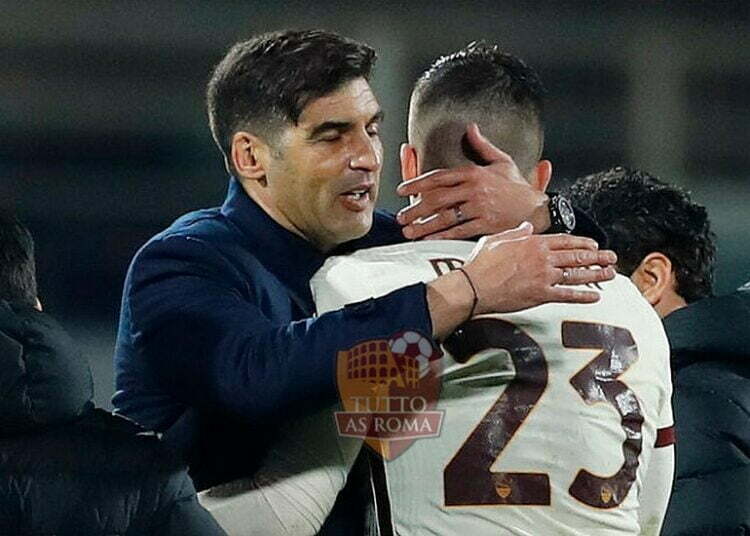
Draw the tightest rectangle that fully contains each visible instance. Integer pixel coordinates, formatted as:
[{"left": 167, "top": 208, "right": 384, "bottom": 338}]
[{"left": 221, "top": 177, "right": 326, "bottom": 314}]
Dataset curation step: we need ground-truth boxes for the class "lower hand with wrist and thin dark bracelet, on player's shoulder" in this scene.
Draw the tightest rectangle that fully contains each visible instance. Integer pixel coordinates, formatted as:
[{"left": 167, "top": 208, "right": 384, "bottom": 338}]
[{"left": 427, "top": 222, "right": 617, "bottom": 340}]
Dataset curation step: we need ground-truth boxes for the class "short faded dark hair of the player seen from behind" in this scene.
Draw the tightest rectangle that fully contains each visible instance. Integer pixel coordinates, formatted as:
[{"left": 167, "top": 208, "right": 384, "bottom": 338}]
[{"left": 409, "top": 42, "right": 545, "bottom": 174}]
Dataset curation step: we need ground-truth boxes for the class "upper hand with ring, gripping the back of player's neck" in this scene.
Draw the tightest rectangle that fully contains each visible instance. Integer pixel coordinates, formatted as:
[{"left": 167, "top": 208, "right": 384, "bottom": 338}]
[{"left": 397, "top": 123, "right": 549, "bottom": 240}]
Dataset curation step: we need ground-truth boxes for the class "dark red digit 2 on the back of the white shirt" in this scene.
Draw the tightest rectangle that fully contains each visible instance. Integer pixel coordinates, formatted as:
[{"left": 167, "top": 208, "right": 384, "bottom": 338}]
[{"left": 443, "top": 318, "right": 550, "bottom": 506}]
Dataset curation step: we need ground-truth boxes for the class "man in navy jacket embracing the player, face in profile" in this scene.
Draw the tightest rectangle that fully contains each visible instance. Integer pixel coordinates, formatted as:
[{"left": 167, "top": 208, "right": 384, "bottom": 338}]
[{"left": 114, "top": 31, "right": 613, "bottom": 534}]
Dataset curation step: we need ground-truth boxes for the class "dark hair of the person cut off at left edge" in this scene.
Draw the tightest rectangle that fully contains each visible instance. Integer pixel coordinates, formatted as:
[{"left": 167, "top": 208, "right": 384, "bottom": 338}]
[{"left": 0, "top": 213, "right": 37, "bottom": 306}]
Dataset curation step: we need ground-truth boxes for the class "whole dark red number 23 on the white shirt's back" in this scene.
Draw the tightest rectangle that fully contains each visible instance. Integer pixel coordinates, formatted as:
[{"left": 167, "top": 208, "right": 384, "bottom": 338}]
[{"left": 443, "top": 318, "right": 643, "bottom": 508}]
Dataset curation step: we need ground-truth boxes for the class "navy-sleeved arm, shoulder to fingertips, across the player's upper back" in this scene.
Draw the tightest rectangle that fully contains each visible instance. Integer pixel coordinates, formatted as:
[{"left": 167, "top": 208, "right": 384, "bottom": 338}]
[{"left": 117, "top": 221, "right": 614, "bottom": 422}]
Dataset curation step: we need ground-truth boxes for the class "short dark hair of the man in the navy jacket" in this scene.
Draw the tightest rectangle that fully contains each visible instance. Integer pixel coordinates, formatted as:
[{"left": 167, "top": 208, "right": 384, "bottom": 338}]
[{"left": 206, "top": 30, "right": 376, "bottom": 158}]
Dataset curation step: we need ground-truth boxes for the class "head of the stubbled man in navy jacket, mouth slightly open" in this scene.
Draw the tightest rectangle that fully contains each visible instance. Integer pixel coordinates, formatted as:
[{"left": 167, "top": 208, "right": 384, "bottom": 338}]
[{"left": 207, "top": 30, "right": 383, "bottom": 250}]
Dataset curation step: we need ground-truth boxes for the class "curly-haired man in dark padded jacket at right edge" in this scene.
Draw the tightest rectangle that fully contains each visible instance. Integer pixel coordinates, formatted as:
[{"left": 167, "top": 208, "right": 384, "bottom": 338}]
[{"left": 569, "top": 167, "right": 750, "bottom": 536}]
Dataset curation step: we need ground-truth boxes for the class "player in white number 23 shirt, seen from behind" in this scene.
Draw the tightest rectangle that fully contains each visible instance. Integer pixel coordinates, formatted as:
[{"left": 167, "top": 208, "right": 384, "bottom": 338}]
[{"left": 201, "top": 45, "right": 671, "bottom": 536}]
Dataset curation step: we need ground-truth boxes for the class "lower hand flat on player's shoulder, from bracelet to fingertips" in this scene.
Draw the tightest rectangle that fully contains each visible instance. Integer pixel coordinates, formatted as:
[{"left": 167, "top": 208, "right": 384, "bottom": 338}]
[{"left": 464, "top": 223, "right": 617, "bottom": 314}]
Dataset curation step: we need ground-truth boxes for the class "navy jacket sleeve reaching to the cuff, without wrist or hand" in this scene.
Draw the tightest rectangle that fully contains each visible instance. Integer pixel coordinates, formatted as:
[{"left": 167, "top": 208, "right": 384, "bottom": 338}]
[{"left": 132, "top": 285, "right": 431, "bottom": 421}]
